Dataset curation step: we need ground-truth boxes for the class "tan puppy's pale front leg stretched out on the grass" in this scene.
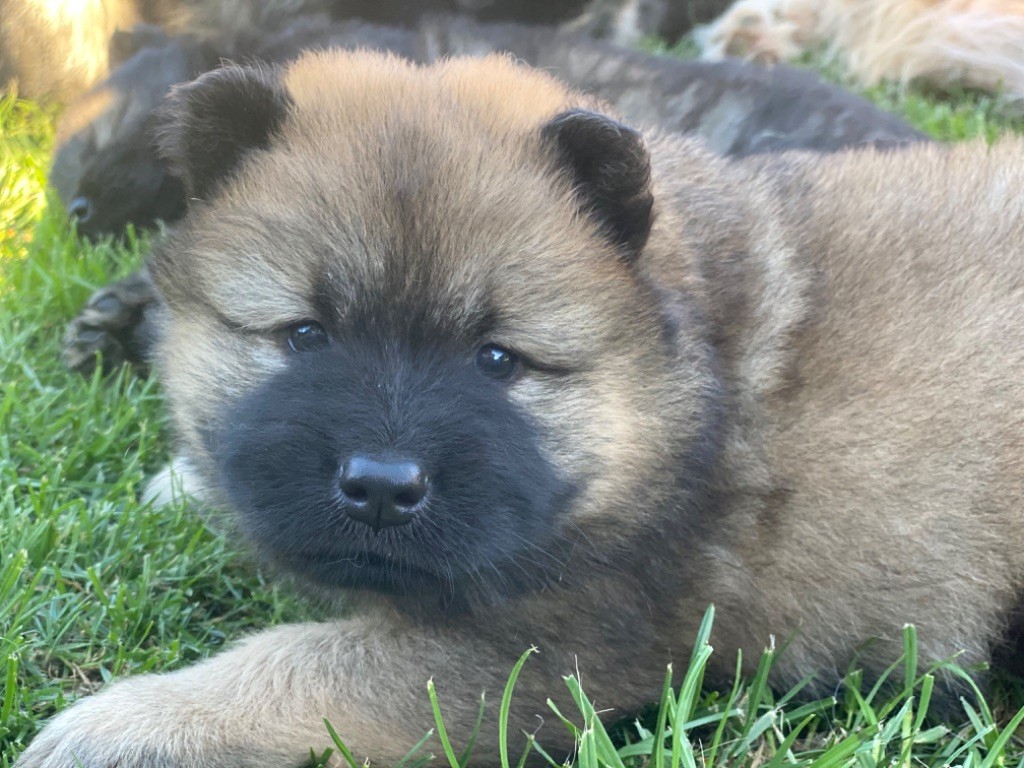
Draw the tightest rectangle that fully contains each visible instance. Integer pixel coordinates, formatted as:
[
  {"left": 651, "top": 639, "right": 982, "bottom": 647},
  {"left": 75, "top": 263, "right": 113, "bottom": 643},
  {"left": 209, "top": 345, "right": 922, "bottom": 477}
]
[{"left": 16, "top": 615, "right": 557, "bottom": 768}]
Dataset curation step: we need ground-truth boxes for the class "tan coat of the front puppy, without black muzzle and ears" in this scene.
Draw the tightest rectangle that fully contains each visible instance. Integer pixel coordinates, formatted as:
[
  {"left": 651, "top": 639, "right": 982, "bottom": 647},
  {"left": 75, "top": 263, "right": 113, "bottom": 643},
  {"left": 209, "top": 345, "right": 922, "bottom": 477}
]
[{"left": 17, "top": 53, "right": 1024, "bottom": 768}]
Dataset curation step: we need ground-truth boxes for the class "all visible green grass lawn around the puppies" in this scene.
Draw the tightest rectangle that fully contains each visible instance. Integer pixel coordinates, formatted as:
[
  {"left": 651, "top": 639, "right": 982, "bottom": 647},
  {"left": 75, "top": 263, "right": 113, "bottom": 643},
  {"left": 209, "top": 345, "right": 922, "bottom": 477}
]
[{"left": 0, "top": 46, "right": 1024, "bottom": 768}]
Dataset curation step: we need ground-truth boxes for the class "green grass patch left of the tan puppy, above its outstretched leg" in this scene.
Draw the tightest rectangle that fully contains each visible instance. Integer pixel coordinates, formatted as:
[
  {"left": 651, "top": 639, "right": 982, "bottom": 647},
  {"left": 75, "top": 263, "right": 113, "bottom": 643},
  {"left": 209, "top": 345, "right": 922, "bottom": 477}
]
[{"left": 0, "top": 98, "right": 301, "bottom": 767}]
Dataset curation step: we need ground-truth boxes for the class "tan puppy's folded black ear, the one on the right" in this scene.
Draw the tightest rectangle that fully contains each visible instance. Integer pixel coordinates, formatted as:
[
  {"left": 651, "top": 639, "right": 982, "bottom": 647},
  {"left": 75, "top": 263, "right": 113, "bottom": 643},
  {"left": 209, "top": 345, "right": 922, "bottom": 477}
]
[{"left": 541, "top": 110, "right": 654, "bottom": 259}]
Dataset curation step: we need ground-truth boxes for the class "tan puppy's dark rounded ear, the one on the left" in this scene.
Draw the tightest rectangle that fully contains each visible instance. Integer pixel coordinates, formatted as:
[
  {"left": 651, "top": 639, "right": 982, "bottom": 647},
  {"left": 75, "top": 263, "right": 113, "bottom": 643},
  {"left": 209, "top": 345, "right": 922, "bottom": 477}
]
[{"left": 157, "top": 66, "right": 292, "bottom": 200}]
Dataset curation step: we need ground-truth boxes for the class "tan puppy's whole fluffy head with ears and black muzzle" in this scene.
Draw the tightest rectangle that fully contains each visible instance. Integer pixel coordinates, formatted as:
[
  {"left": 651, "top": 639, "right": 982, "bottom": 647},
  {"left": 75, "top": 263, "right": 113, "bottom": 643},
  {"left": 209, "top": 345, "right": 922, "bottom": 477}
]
[{"left": 153, "top": 52, "right": 709, "bottom": 605}]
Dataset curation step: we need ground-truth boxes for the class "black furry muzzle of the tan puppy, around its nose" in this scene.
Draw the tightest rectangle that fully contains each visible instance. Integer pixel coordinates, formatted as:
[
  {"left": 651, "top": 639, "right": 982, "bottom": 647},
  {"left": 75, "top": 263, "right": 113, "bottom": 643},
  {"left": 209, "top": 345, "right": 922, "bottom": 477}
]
[{"left": 210, "top": 338, "right": 573, "bottom": 612}]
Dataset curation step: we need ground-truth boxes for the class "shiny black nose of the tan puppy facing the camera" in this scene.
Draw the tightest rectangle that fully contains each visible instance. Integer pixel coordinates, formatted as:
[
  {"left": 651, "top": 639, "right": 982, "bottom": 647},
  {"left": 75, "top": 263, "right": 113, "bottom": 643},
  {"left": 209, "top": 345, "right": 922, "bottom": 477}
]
[{"left": 338, "top": 456, "right": 430, "bottom": 530}]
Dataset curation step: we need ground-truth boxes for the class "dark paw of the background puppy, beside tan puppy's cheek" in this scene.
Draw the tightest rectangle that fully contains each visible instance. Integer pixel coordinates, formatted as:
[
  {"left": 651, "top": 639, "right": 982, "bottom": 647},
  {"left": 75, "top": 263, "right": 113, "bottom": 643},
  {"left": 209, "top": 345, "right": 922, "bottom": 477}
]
[{"left": 61, "top": 272, "right": 157, "bottom": 376}]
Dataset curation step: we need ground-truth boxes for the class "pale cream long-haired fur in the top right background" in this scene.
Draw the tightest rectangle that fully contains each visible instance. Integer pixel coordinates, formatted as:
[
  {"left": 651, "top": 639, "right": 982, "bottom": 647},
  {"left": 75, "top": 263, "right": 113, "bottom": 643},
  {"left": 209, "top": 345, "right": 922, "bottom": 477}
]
[{"left": 698, "top": 0, "right": 1024, "bottom": 100}]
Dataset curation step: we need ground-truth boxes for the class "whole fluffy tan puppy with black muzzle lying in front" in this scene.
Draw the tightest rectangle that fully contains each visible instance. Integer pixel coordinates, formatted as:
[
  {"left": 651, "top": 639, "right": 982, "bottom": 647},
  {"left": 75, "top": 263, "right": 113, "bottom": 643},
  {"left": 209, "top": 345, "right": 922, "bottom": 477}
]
[{"left": 17, "top": 52, "right": 1024, "bottom": 768}]
